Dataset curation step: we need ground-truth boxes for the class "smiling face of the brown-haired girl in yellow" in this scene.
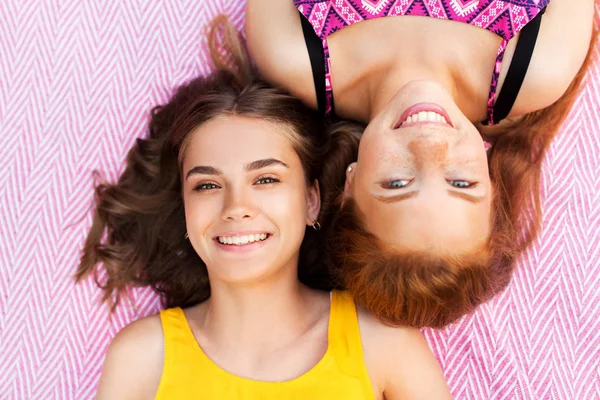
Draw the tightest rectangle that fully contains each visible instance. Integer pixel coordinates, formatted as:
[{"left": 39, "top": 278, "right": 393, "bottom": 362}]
[{"left": 182, "top": 116, "right": 320, "bottom": 283}]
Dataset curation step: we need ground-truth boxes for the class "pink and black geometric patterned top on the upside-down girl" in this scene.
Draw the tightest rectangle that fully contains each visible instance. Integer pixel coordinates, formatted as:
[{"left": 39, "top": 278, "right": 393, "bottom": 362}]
[{"left": 293, "top": 0, "right": 550, "bottom": 123}]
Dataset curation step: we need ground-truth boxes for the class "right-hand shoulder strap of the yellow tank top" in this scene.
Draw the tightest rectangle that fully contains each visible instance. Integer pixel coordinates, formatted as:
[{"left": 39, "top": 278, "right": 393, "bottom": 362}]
[{"left": 329, "top": 290, "right": 372, "bottom": 382}]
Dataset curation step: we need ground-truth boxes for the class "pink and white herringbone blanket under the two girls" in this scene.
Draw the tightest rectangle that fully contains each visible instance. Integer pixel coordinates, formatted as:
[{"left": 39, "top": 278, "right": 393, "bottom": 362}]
[{"left": 0, "top": 0, "right": 600, "bottom": 400}]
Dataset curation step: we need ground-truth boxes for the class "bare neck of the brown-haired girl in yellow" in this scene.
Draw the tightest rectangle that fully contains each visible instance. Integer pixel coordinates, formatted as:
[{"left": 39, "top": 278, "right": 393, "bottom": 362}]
[{"left": 199, "top": 260, "right": 324, "bottom": 353}]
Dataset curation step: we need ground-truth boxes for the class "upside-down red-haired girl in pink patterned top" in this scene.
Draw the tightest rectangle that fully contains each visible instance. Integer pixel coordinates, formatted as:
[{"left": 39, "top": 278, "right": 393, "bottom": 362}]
[{"left": 246, "top": 0, "right": 594, "bottom": 327}]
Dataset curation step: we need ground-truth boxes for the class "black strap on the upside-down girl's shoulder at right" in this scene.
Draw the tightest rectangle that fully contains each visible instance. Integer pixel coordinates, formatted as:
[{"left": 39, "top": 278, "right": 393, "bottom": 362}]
[{"left": 494, "top": 7, "right": 546, "bottom": 123}]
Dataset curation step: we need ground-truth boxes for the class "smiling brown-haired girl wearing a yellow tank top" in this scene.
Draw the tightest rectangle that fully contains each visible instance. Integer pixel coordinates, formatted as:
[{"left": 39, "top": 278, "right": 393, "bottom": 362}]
[{"left": 78, "top": 21, "right": 450, "bottom": 400}]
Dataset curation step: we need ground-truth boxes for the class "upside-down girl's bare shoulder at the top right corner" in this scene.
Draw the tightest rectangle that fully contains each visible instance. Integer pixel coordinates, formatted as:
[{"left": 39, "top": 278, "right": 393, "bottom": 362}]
[{"left": 505, "top": 0, "right": 594, "bottom": 116}]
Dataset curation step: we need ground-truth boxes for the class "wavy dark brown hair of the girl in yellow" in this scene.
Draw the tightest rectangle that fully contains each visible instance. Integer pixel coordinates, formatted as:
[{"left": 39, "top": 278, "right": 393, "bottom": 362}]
[{"left": 76, "top": 17, "right": 358, "bottom": 310}]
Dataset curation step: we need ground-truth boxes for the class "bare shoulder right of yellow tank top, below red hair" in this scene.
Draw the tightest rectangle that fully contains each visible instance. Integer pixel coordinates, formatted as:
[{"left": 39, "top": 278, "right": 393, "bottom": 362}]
[{"left": 358, "top": 308, "right": 452, "bottom": 400}]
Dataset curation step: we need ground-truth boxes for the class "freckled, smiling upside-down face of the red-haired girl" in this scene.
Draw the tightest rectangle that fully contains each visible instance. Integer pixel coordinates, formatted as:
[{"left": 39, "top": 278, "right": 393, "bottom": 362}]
[{"left": 345, "top": 81, "right": 492, "bottom": 253}]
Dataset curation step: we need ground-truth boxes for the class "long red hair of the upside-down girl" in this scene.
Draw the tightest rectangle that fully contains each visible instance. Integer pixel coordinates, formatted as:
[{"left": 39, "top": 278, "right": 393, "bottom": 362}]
[{"left": 328, "top": 26, "right": 598, "bottom": 328}]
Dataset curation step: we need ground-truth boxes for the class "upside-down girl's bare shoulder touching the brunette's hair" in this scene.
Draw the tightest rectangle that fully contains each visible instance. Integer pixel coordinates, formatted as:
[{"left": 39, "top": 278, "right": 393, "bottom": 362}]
[{"left": 245, "top": 0, "right": 317, "bottom": 108}]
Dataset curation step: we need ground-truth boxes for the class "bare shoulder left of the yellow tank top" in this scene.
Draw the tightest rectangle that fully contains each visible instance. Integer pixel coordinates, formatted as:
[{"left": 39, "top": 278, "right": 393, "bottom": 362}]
[{"left": 96, "top": 315, "right": 164, "bottom": 400}]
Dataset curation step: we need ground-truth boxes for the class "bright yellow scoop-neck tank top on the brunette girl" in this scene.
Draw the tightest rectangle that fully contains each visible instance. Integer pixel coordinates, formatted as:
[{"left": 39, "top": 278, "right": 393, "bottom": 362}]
[{"left": 156, "top": 291, "right": 375, "bottom": 400}]
